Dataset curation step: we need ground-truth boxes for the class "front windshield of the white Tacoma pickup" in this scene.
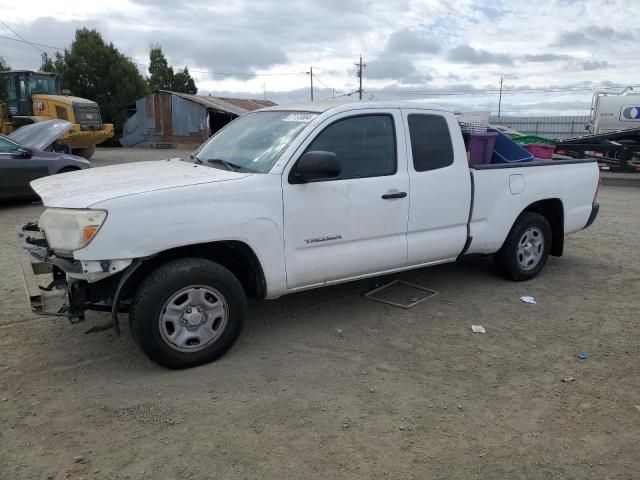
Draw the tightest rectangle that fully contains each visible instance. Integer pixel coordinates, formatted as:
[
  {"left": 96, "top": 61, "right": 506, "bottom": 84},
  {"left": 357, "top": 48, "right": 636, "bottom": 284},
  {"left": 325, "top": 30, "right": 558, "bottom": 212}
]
[{"left": 194, "top": 111, "right": 317, "bottom": 173}]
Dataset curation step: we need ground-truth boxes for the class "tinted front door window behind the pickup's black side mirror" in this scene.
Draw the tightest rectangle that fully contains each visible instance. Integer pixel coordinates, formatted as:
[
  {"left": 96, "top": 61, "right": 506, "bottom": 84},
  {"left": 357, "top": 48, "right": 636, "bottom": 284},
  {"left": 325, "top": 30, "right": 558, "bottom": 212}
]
[{"left": 305, "top": 114, "right": 396, "bottom": 180}]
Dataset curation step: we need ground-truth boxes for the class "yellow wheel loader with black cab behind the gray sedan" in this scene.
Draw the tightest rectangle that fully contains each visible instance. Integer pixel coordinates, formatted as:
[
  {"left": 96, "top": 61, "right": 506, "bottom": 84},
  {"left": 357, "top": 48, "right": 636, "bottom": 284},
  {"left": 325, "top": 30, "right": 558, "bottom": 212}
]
[{"left": 0, "top": 70, "right": 113, "bottom": 158}]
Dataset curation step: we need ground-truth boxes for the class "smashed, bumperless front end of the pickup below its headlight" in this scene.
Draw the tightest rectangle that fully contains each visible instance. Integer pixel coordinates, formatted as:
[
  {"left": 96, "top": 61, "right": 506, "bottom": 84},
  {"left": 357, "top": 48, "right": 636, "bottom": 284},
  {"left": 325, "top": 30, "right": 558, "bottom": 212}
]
[{"left": 18, "top": 222, "right": 138, "bottom": 333}]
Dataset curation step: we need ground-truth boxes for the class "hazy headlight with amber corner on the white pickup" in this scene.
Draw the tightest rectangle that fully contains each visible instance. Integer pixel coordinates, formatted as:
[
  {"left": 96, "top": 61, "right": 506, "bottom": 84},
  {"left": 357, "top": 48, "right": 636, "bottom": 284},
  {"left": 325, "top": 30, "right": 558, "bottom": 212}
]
[{"left": 38, "top": 208, "right": 107, "bottom": 254}]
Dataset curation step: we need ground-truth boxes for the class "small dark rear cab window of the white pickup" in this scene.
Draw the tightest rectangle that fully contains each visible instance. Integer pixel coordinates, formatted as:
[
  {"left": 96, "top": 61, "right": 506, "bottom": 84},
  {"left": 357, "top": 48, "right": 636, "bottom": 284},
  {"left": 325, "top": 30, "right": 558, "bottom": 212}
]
[{"left": 407, "top": 113, "right": 453, "bottom": 172}]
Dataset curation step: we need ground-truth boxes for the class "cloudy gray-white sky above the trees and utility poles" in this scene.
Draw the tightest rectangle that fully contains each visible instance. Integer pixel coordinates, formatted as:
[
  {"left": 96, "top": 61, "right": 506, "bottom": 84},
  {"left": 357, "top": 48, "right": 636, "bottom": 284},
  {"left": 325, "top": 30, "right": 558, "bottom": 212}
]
[{"left": 0, "top": 0, "right": 640, "bottom": 114}]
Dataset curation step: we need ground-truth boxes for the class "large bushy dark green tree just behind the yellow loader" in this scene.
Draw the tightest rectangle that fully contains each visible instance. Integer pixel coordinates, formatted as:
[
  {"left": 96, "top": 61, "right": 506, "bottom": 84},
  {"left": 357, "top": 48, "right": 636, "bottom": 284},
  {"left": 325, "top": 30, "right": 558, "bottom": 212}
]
[{"left": 52, "top": 28, "right": 149, "bottom": 132}]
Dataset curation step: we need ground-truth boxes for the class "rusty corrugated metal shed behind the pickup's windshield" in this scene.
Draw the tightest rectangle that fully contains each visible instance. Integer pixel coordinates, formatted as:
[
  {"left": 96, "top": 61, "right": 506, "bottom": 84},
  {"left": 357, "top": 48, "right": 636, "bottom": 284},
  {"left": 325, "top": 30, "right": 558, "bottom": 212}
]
[{"left": 120, "top": 90, "right": 276, "bottom": 148}]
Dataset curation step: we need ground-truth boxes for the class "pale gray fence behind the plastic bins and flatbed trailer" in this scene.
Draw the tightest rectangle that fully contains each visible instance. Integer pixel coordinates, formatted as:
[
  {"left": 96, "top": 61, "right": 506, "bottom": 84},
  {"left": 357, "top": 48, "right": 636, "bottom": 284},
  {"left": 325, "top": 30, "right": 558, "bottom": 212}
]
[{"left": 489, "top": 115, "right": 589, "bottom": 140}]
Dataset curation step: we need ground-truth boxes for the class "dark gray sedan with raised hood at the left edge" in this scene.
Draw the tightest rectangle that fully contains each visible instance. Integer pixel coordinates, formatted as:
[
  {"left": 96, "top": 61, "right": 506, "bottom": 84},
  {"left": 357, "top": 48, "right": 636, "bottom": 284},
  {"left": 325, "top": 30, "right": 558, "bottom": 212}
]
[{"left": 0, "top": 120, "right": 91, "bottom": 200}]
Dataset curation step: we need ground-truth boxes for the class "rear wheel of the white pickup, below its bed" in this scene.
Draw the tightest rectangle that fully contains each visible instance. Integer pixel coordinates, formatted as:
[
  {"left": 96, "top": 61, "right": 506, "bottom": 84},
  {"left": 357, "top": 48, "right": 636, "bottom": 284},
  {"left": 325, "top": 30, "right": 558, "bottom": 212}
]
[{"left": 493, "top": 212, "right": 551, "bottom": 282}]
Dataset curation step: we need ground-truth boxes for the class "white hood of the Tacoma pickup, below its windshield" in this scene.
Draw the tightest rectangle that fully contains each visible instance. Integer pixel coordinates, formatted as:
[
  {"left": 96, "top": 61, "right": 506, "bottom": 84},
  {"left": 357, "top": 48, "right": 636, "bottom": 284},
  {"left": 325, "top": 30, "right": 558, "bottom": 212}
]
[{"left": 31, "top": 159, "right": 251, "bottom": 208}]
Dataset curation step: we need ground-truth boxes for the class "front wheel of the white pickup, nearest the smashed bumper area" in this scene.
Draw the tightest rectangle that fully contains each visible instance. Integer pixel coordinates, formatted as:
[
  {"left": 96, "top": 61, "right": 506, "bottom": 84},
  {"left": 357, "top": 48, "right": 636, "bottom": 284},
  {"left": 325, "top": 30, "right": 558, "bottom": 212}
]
[{"left": 129, "top": 258, "right": 247, "bottom": 369}]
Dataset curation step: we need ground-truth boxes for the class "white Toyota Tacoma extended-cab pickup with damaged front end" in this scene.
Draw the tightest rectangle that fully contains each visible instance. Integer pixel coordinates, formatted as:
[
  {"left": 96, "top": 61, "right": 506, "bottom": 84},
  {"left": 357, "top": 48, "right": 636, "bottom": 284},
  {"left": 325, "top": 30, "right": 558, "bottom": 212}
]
[{"left": 20, "top": 102, "right": 599, "bottom": 368}]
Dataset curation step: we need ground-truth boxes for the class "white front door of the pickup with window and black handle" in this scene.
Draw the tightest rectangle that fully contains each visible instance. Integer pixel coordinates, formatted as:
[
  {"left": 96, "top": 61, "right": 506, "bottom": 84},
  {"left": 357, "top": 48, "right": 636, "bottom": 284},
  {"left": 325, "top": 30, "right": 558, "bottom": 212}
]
[{"left": 282, "top": 109, "right": 409, "bottom": 290}]
